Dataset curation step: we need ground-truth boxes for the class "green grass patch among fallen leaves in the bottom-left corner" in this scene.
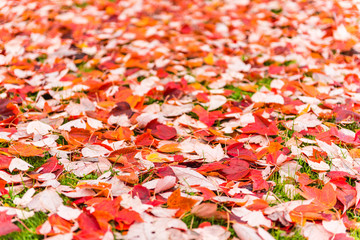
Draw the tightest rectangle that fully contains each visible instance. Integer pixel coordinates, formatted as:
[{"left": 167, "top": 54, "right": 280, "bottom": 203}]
[{"left": 0, "top": 212, "right": 47, "bottom": 240}]
